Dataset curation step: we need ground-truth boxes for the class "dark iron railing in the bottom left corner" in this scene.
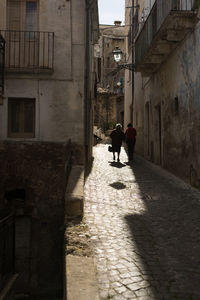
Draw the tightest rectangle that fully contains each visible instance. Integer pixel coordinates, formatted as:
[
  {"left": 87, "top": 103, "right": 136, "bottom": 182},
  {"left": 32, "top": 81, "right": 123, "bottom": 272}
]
[{"left": 0, "top": 215, "right": 15, "bottom": 290}]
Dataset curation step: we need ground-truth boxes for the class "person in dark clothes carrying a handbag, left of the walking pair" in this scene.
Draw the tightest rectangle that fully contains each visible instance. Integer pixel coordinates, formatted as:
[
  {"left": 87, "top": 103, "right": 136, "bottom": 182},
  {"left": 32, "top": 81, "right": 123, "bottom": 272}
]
[{"left": 110, "top": 124, "right": 125, "bottom": 162}]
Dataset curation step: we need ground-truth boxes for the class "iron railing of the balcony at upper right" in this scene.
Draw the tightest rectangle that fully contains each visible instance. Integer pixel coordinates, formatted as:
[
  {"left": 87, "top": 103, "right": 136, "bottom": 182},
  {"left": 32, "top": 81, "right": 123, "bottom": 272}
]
[{"left": 135, "top": 0, "right": 196, "bottom": 65}]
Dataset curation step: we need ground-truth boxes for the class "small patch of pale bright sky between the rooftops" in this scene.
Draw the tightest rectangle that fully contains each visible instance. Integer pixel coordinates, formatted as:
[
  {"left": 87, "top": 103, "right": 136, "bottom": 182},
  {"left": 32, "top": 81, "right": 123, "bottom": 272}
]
[{"left": 98, "top": 0, "right": 125, "bottom": 25}]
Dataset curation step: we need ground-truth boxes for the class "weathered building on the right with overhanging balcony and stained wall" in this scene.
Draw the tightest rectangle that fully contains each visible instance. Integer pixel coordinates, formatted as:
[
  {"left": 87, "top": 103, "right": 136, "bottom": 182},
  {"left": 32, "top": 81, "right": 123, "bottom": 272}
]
[{"left": 125, "top": 0, "right": 200, "bottom": 187}]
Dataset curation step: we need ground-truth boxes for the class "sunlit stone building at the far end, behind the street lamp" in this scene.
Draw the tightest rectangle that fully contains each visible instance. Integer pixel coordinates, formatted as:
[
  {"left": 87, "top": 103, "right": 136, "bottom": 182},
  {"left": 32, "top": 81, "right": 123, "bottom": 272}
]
[{"left": 94, "top": 21, "right": 125, "bottom": 129}]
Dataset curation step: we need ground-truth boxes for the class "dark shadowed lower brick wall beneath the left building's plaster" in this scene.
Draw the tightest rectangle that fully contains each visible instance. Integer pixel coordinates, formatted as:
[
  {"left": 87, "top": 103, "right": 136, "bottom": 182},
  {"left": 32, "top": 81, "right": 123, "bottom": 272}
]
[{"left": 0, "top": 142, "right": 71, "bottom": 297}]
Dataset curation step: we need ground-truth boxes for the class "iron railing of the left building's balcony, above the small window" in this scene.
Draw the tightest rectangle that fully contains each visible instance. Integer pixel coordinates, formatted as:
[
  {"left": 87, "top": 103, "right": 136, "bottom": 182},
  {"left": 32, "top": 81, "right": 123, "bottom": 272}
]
[{"left": 0, "top": 30, "right": 54, "bottom": 71}]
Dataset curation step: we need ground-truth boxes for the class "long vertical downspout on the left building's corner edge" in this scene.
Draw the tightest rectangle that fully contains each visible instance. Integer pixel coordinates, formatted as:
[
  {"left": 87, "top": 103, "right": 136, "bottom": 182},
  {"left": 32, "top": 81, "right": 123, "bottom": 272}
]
[{"left": 84, "top": 0, "right": 91, "bottom": 164}]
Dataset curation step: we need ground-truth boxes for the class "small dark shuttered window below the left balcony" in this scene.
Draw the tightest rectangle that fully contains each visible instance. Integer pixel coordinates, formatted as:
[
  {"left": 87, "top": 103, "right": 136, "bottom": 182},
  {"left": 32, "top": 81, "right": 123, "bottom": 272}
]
[{"left": 8, "top": 98, "right": 35, "bottom": 138}]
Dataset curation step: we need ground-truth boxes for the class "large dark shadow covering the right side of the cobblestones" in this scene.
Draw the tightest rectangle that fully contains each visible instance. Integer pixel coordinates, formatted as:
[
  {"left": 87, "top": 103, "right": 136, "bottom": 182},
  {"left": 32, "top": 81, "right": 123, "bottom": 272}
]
[{"left": 125, "top": 157, "right": 200, "bottom": 300}]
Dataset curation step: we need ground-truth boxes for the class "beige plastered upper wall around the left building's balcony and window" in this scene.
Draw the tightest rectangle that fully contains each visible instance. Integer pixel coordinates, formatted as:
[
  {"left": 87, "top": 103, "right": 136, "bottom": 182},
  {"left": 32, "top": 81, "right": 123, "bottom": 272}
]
[{"left": 0, "top": 0, "right": 85, "bottom": 145}]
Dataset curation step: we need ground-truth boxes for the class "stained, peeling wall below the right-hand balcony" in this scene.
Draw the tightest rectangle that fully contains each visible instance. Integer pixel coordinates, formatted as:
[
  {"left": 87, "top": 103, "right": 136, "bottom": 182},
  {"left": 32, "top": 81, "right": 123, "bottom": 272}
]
[{"left": 134, "top": 23, "right": 200, "bottom": 188}]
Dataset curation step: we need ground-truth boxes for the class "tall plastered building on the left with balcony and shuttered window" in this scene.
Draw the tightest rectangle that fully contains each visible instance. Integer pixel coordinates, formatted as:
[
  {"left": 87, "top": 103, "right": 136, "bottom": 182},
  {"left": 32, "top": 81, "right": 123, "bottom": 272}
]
[{"left": 0, "top": 0, "right": 98, "bottom": 299}]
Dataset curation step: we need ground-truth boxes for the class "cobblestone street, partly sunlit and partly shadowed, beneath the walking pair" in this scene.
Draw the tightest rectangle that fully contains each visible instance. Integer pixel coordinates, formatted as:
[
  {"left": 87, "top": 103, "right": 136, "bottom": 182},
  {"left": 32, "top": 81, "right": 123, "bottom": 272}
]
[{"left": 85, "top": 144, "right": 200, "bottom": 300}]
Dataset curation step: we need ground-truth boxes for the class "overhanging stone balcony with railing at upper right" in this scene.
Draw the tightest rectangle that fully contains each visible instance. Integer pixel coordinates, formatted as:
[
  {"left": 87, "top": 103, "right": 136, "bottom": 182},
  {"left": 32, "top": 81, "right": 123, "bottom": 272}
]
[{"left": 135, "top": 0, "right": 198, "bottom": 76}]
